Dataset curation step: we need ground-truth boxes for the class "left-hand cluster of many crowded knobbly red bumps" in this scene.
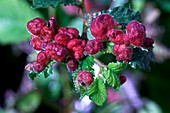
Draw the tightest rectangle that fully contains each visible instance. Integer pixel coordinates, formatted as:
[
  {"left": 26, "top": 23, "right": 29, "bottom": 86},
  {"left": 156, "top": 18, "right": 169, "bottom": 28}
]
[{"left": 27, "top": 17, "right": 86, "bottom": 72}]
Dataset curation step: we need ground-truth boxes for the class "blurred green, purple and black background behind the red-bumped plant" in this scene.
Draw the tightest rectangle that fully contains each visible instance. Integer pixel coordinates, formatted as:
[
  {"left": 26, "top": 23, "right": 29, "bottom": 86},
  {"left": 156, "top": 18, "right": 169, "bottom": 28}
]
[{"left": 0, "top": 0, "right": 170, "bottom": 113}]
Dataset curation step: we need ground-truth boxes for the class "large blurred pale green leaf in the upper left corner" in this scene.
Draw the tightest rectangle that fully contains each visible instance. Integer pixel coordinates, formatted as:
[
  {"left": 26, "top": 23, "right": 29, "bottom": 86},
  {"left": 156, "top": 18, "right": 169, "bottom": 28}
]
[{"left": 0, "top": 0, "right": 42, "bottom": 45}]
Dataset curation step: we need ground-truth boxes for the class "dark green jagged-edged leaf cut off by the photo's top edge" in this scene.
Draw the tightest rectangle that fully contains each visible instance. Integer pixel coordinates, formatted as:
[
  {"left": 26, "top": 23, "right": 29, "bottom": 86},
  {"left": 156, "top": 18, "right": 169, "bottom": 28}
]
[{"left": 32, "top": 0, "right": 78, "bottom": 8}]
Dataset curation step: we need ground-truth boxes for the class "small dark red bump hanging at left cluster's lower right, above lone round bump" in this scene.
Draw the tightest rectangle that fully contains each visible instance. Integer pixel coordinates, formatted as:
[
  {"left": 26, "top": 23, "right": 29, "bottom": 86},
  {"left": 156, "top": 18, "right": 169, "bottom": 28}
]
[{"left": 66, "top": 58, "right": 78, "bottom": 71}]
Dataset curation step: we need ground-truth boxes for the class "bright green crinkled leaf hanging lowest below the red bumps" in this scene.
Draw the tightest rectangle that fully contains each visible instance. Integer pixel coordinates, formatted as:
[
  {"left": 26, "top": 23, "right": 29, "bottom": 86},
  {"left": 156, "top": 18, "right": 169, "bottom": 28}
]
[{"left": 89, "top": 78, "right": 107, "bottom": 106}]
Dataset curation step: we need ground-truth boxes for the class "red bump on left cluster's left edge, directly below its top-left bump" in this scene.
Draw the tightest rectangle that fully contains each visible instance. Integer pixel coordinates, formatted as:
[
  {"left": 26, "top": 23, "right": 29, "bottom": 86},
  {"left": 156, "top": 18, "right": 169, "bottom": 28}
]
[{"left": 30, "top": 35, "right": 44, "bottom": 50}]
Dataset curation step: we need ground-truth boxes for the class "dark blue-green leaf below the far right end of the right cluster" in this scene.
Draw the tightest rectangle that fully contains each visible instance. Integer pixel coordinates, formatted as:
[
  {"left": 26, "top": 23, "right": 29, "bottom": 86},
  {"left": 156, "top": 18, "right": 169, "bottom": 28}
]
[{"left": 129, "top": 48, "right": 155, "bottom": 71}]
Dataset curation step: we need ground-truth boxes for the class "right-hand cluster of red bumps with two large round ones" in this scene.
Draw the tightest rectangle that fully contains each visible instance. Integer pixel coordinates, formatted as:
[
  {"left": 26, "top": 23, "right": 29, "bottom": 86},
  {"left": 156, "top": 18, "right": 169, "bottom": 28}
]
[{"left": 90, "top": 14, "right": 154, "bottom": 62}]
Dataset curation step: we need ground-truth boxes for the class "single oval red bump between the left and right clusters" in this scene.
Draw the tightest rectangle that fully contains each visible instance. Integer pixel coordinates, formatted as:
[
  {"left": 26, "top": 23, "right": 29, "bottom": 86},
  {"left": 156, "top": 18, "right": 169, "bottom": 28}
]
[{"left": 84, "top": 39, "right": 104, "bottom": 55}]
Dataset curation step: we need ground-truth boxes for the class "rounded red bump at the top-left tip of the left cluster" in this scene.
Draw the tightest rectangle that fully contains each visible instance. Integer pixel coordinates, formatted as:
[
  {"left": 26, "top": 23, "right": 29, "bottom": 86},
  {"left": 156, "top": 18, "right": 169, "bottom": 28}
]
[{"left": 27, "top": 18, "right": 46, "bottom": 35}]
